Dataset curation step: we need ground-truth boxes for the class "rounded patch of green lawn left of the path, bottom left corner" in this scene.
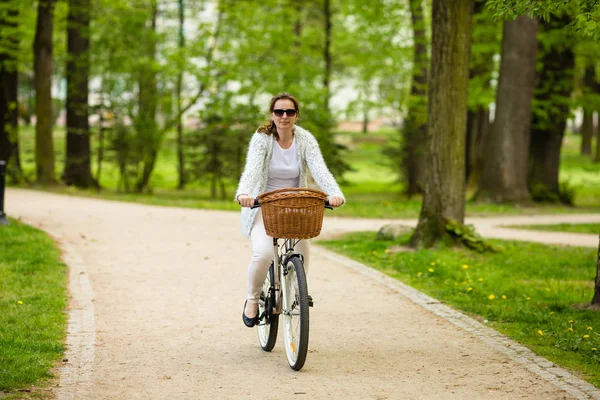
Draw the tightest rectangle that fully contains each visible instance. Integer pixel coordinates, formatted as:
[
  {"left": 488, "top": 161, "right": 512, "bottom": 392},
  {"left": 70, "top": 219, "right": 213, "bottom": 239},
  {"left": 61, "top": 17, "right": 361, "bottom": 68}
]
[{"left": 0, "top": 220, "right": 67, "bottom": 399}]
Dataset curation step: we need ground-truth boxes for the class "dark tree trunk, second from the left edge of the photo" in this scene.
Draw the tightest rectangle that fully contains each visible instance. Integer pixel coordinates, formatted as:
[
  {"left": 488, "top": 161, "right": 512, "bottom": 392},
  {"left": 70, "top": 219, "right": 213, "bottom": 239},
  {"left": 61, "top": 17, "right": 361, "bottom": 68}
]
[{"left": 33, "top": 0, "right": 56, "bottom": 185}]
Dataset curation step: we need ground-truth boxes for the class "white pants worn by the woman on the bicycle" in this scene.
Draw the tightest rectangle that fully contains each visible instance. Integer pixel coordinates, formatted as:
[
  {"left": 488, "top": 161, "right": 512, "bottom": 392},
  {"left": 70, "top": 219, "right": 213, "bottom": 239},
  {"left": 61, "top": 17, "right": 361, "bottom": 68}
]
[{"left": 248, "top": 210, "right": 310, "bottom": 303}]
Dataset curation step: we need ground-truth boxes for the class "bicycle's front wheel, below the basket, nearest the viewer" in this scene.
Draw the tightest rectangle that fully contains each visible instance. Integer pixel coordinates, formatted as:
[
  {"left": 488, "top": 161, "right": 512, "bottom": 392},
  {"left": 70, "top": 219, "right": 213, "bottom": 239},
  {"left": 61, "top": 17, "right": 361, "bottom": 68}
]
[{"left": 281, "top": 257, "right": 309, "bottom": 371}]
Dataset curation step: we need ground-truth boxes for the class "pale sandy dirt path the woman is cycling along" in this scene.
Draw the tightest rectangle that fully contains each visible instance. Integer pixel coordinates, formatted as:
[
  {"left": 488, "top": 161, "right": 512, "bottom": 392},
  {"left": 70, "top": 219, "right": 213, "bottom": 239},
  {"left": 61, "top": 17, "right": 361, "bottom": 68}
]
[{"left": 6, "top": 189, "right": 600, "bottom": 400}]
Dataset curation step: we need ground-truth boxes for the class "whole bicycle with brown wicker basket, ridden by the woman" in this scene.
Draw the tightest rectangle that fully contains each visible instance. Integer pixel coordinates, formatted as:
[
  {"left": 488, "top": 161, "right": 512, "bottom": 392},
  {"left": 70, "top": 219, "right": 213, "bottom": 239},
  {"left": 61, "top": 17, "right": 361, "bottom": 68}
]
[{"left": 253, "top": 188, "right": 333, "bottom": 371}]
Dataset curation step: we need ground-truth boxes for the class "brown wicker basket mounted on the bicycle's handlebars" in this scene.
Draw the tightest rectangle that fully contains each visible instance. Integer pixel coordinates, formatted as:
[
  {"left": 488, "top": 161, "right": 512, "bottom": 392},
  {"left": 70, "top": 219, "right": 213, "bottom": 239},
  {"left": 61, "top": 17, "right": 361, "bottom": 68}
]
[{"left": 258, "top": 188, "right": 327, "bottom": 239}]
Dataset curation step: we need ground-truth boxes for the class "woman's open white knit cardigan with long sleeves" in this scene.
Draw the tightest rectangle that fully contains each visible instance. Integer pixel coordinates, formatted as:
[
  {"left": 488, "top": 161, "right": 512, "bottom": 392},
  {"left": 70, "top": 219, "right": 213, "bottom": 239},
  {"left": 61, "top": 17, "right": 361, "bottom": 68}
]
[{"left": 235, "top": 125, "right": 345, "bottom": 237}]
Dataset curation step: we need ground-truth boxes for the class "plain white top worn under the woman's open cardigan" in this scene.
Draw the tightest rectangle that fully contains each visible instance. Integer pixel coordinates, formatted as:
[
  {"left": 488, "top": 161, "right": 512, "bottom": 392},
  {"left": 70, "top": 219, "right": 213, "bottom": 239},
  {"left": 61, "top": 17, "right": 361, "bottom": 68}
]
[{"left": 266, "top": 137, "right": 300, "bottom": 192}]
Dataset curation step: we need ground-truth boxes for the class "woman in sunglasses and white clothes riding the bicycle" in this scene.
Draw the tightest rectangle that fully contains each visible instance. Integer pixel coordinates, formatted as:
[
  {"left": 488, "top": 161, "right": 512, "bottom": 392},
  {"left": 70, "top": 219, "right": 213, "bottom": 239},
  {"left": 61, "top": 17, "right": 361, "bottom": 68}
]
[{"left": 235, "top": 93, "right": 345, "bottom": 328}]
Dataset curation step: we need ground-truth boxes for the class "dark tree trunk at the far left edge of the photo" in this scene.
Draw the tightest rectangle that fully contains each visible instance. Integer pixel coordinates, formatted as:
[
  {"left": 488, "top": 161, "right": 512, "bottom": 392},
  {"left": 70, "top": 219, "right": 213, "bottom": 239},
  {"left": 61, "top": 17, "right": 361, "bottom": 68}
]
[{"left": 0, "top": 1, "right": 23, "bottom": 181}]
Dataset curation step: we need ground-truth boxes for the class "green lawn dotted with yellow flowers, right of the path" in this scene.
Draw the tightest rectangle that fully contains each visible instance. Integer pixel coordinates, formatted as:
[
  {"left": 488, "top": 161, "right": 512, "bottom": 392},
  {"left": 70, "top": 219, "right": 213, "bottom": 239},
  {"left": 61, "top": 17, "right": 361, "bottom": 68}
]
[{"left": 319, "top": 232, "right": 600, "bottom": 387}]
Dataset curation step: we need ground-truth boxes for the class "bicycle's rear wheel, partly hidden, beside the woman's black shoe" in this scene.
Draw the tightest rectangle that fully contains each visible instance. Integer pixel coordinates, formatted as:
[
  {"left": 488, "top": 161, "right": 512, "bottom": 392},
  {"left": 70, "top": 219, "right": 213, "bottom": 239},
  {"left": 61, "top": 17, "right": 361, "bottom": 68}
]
[{"left": 258, "top": 264, "right": 279, "bottom": 351}]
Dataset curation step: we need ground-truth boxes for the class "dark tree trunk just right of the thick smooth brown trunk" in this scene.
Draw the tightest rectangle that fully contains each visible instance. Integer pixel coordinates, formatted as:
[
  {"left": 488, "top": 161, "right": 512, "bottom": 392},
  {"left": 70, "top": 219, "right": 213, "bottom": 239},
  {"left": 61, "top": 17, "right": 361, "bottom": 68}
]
[{"left": 529, "top": 14, "right": 575, "bottom": 200}]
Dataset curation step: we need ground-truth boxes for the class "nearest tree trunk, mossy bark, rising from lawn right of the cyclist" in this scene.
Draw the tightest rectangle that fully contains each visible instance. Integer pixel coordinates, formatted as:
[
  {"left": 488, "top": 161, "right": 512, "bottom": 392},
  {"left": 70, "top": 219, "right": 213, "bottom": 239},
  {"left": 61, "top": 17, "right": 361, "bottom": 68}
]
[{"left": 411, "top": 0, "right": 473, "bottom": 247}]
